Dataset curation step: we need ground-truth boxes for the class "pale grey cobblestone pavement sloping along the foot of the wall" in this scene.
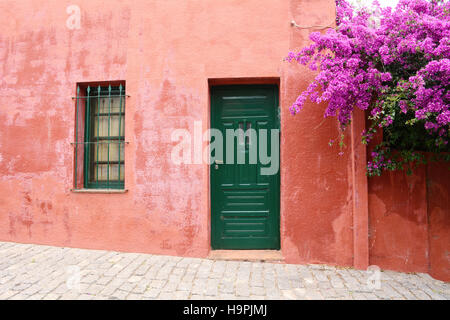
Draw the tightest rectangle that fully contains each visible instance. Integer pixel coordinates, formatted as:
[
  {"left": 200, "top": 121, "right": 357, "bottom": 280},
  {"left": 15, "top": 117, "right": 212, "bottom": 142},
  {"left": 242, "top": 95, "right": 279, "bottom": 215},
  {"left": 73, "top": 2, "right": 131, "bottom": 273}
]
[{"left": 0, "top": 242, "right": 450, "bottom": 300}]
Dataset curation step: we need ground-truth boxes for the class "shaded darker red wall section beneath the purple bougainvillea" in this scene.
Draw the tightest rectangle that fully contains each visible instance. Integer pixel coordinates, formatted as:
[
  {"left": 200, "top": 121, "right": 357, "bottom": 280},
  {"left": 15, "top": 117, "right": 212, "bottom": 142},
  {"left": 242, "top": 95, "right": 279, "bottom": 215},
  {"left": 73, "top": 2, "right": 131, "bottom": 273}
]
[{"left": 369, "top": 163, "right": 450, "bottom": 281}]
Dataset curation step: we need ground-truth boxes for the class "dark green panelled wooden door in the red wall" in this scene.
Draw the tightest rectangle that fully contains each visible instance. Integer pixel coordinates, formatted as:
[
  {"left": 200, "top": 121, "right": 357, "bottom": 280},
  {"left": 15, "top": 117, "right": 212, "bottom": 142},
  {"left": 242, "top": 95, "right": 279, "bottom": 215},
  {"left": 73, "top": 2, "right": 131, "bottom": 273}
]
[{"left": 210, "top": 85, "right": 280, "bottom": 249}]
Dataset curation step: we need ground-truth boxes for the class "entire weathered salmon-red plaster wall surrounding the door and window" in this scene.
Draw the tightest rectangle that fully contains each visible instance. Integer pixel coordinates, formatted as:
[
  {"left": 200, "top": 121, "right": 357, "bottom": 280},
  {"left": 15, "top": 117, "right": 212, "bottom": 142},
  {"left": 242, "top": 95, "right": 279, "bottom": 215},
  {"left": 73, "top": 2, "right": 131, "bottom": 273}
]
[{"left": 0, "top": 0, "right": 449, "bottom": 280}]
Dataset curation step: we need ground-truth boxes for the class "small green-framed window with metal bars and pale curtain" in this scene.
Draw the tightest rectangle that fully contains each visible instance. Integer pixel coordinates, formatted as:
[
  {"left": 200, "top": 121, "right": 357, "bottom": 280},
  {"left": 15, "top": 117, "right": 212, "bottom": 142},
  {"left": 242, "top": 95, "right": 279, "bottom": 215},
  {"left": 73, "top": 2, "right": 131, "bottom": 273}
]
[{"left": 77, "top": 85, "right": 125, "bottom": 189}]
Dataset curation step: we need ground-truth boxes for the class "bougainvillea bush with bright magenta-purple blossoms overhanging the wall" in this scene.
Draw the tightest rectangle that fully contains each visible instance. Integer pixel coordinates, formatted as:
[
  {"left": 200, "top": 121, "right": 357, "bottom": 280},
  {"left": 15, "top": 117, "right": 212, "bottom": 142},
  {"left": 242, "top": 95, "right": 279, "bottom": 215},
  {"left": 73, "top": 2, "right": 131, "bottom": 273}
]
[{"left": 287, "top": 0, "right": 450, "bottom": 176}]
